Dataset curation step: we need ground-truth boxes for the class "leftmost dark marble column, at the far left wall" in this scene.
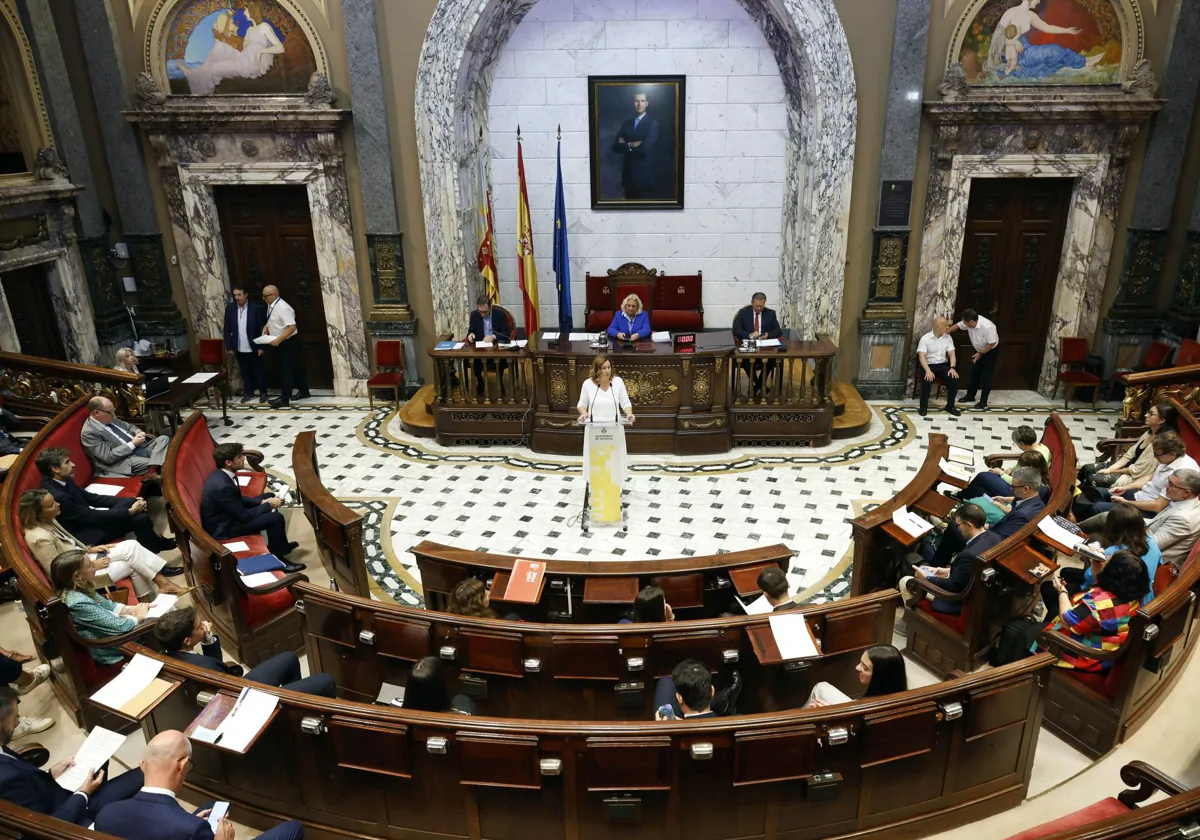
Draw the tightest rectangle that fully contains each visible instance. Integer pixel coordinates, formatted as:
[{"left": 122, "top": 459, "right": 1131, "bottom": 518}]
[{"left": 18, "top": 0, "right": 124, "bottom": 361}]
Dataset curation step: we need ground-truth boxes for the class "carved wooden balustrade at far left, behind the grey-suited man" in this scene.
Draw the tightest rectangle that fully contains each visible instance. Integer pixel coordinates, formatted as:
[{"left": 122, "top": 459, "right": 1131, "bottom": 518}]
[{"left": 0, "top": 353, "right": 145, "bottom": 418}]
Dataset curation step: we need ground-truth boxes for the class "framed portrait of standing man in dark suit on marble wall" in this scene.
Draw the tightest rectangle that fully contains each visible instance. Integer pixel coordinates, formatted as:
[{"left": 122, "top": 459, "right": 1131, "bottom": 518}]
[{"left": 588, "top": 76, "right": 688, "bottom": 210}]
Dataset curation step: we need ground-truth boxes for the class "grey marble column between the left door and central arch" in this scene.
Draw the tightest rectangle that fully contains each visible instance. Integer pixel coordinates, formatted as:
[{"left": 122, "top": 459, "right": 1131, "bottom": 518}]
[{"left": 342, "top": 0, "right": 421, "bottom": 395}]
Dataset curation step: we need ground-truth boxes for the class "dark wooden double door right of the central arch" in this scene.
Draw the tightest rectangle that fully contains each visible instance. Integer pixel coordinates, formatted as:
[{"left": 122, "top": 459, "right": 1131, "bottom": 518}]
[{"left": 954, "top": 178, "right": 1074, "bottom": 390}]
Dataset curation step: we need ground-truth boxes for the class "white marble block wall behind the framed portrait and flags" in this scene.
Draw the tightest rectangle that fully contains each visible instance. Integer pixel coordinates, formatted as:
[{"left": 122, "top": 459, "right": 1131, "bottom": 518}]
[{"left": 487, "top": 0, "right": 787, "bottom": 326}]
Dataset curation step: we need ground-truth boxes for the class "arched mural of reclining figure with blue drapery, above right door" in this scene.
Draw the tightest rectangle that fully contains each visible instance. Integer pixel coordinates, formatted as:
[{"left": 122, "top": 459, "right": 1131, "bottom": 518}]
[{"left": 948, "top": 0, "right": 1142, "bottom": 85}]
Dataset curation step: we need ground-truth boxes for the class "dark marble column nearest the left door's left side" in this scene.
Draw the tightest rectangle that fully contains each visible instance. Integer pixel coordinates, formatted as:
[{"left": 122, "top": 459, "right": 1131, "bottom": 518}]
[{"left": 74, "top": 0, "right": 187, "bottom": 343}]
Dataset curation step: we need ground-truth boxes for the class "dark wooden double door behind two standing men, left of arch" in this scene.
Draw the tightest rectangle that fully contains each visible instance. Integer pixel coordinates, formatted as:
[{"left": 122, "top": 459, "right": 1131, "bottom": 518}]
[{"left": 214, "top": 186, "right": 334, "bottom": 388}]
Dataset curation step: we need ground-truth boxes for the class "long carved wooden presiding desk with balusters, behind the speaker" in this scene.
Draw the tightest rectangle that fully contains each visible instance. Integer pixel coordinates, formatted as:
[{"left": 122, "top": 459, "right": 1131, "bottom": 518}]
[{"left": 430, "top": 330, "right": 838, "bottom": 455}]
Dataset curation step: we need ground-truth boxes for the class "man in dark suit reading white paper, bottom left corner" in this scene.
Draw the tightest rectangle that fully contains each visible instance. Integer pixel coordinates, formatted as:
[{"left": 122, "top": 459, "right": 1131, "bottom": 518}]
[{"left": 0, "top": 685, "right": 142, "bottom": 825}]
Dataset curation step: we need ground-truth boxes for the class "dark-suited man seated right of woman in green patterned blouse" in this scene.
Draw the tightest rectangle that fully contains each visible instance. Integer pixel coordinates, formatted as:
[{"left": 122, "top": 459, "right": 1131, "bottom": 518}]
[{"left": 154, "top": 607, "right": 337, "bottom": 697}]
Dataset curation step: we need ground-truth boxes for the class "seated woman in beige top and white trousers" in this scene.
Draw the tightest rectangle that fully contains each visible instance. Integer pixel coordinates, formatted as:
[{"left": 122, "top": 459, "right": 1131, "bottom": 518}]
[{"left": 17, "top": 490, "right": 185, "bottom": 601}]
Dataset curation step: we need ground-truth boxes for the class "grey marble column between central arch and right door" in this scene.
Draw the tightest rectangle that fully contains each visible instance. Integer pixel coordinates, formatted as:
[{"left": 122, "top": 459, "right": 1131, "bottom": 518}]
[{"left": 854, "top": 0, "right": 930, "bottom": 400}]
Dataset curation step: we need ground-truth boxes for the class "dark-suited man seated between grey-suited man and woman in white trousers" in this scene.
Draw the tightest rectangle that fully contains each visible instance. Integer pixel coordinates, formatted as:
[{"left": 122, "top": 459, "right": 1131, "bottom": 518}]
[{"left": 34, "top": 446, "right": 184, "bottom": 556}]
